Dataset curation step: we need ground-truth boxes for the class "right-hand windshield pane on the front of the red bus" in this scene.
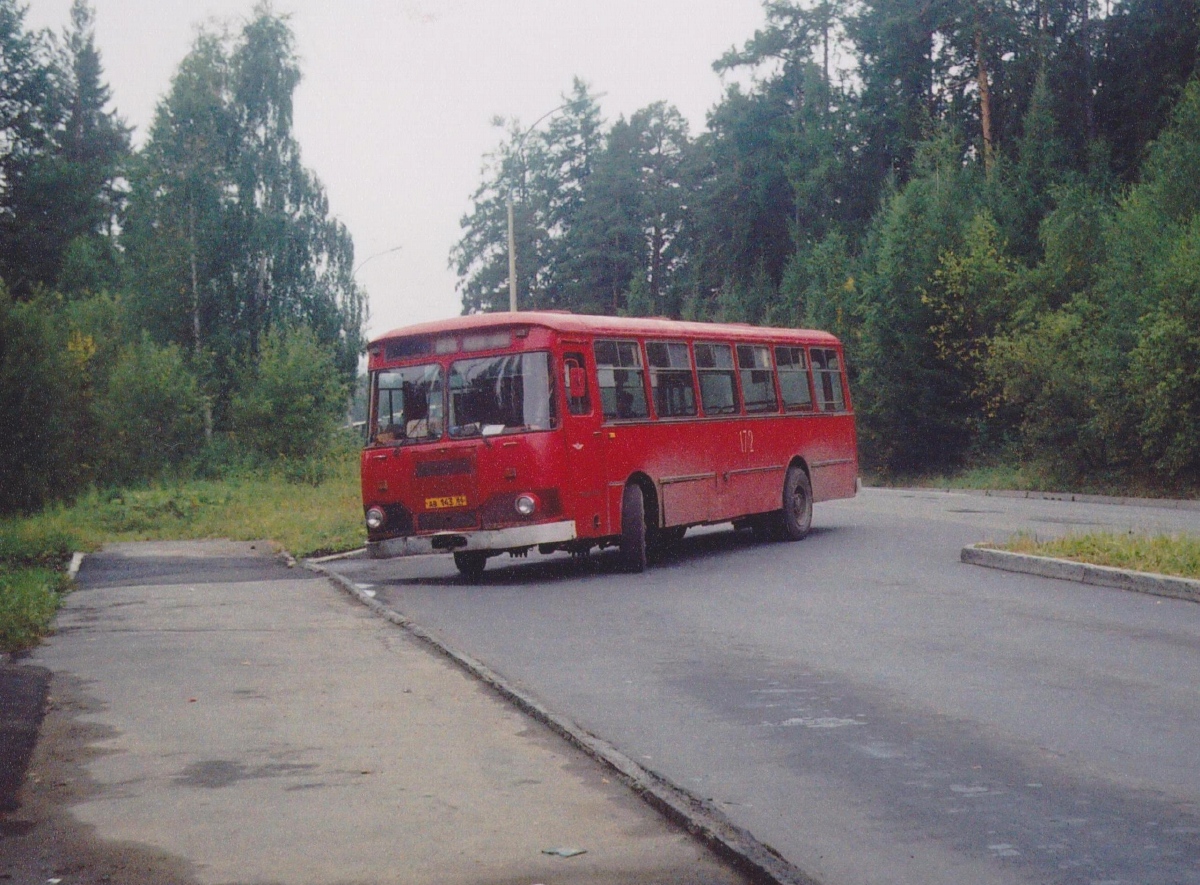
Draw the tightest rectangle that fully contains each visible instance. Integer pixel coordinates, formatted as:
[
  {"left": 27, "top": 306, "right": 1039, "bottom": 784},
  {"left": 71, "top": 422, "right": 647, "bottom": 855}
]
[{"left": 450, "top": 353, "right": 558, "bottom": 437}]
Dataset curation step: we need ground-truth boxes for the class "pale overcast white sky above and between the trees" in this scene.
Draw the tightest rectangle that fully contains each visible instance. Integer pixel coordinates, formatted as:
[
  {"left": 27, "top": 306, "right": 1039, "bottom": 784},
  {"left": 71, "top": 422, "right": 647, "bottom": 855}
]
[{"left": 25, "top": 0, "right": 763, "bottom": 337}]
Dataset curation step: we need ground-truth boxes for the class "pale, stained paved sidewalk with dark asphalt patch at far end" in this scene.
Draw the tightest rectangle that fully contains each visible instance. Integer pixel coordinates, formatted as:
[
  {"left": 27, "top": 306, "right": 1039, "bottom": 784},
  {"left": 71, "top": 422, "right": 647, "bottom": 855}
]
[{"left": 0, "top": 542, "right": 743, "bottom": 885}]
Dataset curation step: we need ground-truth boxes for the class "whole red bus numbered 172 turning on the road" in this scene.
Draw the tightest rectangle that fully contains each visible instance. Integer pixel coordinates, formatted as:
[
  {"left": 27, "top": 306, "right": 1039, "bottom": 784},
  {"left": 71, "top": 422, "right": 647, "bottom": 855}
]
[{"left": 362, "top": 312, "right": 858, "bottom": 578}]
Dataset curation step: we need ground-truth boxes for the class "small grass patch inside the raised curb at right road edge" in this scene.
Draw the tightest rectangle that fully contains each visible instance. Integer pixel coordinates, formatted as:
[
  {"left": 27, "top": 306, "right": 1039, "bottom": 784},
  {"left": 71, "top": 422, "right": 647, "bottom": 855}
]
[{"left": 998, "top": 532, "right": 1200, "bottom": 579}]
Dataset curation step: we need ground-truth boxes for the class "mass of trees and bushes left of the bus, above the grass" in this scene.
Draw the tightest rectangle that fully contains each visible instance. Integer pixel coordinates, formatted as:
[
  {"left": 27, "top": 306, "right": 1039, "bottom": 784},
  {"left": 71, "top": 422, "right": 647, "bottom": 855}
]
[{"left": 0, "top": 0, "right": 366, "bottom": 513}]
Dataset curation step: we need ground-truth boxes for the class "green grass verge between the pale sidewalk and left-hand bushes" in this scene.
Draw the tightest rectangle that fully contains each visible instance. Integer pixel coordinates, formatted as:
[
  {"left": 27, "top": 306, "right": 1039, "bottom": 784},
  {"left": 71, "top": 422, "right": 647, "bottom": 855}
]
[{"left": 0, "top": 452, "right": 366, "bottom": 652}]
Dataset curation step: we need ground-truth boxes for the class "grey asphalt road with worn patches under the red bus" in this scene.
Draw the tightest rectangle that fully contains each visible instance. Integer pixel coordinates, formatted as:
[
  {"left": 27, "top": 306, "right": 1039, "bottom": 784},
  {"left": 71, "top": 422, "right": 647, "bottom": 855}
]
[{"left": 331, "top": 489, "right": 1200, "bottom": 885}]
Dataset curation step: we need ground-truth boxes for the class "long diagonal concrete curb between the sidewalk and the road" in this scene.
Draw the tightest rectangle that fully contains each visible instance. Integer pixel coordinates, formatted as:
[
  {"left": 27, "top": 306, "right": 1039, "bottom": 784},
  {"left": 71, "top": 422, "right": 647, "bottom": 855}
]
[{"left": 302, "top": 560, "right": 820, "bottom": 885}]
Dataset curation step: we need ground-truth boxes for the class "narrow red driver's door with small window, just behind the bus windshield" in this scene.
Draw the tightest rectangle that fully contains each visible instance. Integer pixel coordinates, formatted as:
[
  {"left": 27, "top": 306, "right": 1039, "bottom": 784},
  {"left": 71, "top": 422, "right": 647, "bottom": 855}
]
[{"left": 563, "top": 348, "right": 604, "bottom": 537}]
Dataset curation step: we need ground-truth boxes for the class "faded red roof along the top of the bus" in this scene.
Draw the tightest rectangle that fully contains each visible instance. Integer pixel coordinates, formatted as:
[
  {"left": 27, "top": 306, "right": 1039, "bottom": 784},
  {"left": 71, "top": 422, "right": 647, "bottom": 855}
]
[{"left": 371, "top": 311, "right": 838, "bottom": 345}]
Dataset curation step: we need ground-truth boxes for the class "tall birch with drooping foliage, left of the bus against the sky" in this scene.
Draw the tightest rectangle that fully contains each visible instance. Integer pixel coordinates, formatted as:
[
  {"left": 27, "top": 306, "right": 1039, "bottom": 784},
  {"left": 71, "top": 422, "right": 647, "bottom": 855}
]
[{"left": 127, "top": 5, "right": 366, "bottom": 429}]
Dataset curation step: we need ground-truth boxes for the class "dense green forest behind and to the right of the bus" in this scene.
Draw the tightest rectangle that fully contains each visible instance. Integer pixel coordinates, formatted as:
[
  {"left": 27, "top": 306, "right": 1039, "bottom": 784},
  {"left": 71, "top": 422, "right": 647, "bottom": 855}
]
[{"left": 451, "top": 0, "right": 1200, "bottom": 492}]
